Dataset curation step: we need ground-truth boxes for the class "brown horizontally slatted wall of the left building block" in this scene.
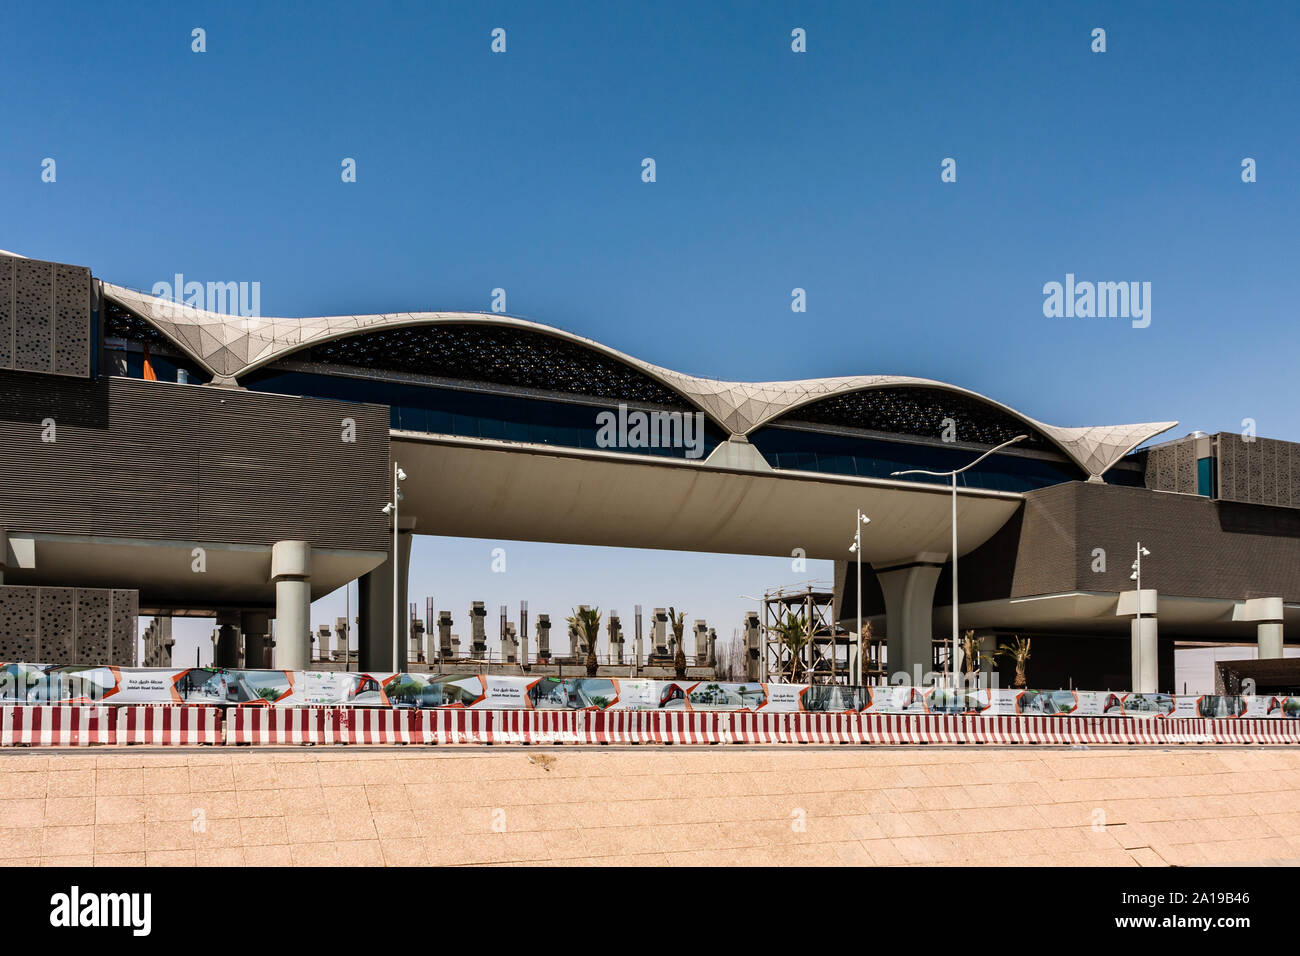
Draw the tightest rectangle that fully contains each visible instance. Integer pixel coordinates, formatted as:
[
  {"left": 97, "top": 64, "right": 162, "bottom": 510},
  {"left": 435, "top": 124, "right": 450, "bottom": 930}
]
[{"left": 0, "top": 372, "right": 389, "bottom": 550}]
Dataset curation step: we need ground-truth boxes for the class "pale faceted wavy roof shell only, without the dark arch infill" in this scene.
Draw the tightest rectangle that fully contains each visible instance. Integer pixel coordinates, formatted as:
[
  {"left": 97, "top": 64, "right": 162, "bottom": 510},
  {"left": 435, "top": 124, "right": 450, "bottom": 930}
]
[{"left": 103, "top": 282, "right": 1178, "bottom": 479}]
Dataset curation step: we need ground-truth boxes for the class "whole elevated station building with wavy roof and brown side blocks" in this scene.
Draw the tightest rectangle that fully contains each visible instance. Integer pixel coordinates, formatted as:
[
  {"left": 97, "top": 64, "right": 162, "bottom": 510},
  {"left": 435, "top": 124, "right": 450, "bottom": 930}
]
[{"left": 0, "top": 255, "right": 1300, "bottom": 691}]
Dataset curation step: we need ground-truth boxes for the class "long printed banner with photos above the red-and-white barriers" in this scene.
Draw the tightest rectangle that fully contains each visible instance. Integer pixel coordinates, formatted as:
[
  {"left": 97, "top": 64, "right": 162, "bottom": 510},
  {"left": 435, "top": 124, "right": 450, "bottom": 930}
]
[{"left": 0, "top": 662, "right": 1300, "bottom": 719}]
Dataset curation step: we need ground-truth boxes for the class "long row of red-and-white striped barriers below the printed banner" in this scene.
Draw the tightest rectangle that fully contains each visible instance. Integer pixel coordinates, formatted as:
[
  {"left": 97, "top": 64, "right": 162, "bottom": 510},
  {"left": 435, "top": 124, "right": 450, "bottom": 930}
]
[{"left": 10, "top": 705, "right": 1300, "bottom": 747}]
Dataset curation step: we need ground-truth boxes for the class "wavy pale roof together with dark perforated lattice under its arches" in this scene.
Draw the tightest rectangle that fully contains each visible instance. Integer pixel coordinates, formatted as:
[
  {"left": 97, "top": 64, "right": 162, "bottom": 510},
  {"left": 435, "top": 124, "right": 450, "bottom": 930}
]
[{"left": 103, "top": 282, "right": 1178, "bottom": 479}]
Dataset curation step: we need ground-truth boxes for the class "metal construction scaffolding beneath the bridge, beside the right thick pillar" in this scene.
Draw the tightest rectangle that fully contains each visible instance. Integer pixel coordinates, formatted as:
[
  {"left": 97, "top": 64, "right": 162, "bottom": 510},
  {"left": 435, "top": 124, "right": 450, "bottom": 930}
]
[{"left": 762, "top": 583, "right": 885, "bottom": 684}]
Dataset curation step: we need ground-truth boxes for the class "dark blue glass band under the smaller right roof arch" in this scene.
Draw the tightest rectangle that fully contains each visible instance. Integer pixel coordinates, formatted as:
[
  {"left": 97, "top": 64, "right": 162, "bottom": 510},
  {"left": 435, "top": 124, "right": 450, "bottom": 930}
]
[{"left": 749, "top": 425, "right": 1087, "bottom": 492}]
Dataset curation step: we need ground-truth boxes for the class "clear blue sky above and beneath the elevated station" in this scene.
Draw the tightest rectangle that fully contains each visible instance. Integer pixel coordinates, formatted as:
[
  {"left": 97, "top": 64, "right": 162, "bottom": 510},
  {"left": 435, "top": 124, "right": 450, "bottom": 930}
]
[{"left": 0, "top": 1, "right": 1300, "bottom": 660}]
